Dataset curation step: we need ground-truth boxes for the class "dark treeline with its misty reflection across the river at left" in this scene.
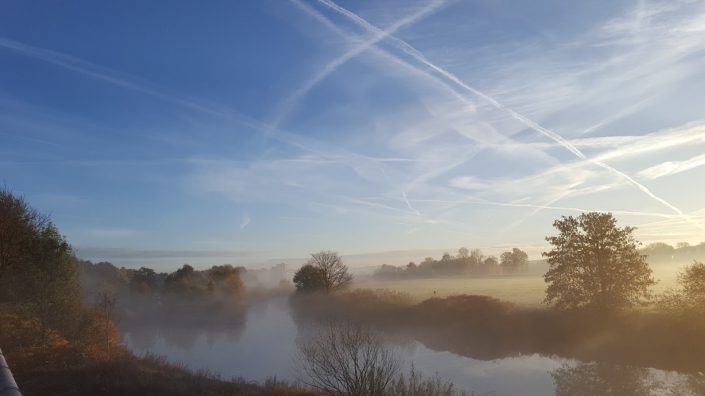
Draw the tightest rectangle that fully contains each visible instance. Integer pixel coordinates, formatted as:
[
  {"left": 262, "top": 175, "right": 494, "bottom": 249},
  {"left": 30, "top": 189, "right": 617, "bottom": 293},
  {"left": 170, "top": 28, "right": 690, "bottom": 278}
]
[{"left": 78, "top": 260, "right": 292, "bottom": 322}]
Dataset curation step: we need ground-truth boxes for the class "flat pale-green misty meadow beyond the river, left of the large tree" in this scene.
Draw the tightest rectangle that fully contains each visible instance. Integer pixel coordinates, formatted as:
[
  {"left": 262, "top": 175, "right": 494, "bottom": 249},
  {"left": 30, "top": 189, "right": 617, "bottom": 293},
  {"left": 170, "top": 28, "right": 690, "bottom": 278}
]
[{"left": 353, "top": 268, "right": 676, "bottom": 307}]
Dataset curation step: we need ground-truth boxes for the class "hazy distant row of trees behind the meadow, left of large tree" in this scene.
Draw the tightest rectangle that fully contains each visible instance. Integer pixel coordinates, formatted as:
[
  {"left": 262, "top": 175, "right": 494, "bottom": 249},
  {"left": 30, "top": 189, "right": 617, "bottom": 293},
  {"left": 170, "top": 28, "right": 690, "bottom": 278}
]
[{"left": 373, "top": 248, "right": 529, "bottom": 279}]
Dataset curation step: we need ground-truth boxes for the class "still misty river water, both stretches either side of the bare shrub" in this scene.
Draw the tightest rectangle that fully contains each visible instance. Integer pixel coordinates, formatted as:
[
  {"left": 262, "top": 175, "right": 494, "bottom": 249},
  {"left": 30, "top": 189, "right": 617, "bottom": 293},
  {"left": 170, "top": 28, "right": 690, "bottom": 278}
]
[{"left": 121, "top": 299, "right": 705, "bottom": 396}]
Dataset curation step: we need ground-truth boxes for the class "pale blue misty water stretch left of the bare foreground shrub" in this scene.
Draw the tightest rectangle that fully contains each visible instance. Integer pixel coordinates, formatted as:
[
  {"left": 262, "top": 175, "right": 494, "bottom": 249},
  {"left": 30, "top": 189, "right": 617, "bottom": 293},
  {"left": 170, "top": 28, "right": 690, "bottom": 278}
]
[{"left": 121, "top": 299, "right": 296, "bottom": 381}]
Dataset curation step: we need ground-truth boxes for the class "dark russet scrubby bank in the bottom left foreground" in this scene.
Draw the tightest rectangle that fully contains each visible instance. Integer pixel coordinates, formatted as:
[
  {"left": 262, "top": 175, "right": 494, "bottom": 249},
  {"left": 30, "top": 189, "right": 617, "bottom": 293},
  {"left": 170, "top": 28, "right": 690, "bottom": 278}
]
[{"left": 0, "top": 305, "right": 316, "bottom": 396}]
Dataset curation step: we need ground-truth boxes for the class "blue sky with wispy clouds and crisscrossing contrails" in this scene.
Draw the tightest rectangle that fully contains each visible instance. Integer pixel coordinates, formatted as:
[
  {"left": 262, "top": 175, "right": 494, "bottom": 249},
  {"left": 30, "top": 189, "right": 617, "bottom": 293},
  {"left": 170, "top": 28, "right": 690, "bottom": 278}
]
[{"left": 0, "top": 0, "right": 705, "bottom": 267}]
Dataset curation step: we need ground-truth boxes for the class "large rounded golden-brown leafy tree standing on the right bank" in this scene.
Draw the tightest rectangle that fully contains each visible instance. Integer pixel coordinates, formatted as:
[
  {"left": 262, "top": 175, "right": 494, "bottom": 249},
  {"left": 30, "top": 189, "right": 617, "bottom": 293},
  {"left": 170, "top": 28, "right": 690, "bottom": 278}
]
[{"left": 543, "top": 212, "right": 656, "bottom": 309}]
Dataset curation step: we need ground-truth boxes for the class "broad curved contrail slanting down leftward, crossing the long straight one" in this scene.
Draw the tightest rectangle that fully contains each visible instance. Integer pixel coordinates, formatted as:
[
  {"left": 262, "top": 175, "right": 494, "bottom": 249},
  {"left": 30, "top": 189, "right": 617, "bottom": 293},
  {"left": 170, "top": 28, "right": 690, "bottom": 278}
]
[{"left": 265, "top": 0, "right": 445, "bottom": 135}]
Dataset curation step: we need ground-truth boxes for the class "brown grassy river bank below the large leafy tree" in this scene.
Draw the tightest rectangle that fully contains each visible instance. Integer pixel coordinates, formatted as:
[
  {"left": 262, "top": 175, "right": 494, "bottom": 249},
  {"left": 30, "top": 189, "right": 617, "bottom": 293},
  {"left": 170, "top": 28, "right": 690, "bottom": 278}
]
[{"left": 292, "top": 290, "right": 705, "bottom": 372}]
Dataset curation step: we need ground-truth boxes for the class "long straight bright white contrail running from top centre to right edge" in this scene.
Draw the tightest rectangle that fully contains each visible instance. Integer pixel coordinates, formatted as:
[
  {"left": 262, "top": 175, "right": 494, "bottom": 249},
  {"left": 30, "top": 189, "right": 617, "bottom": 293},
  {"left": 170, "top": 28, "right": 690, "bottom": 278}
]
[{"left": 318, "top": 0, "right": 705, "bottom": 230}]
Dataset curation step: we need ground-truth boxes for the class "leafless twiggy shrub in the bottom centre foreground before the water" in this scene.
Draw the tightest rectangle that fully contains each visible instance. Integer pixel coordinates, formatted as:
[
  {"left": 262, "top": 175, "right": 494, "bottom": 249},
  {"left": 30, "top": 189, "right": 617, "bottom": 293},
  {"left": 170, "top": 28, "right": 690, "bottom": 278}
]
[{"left": 298, "top": 324, "right": 399, "bottom": 396}]
